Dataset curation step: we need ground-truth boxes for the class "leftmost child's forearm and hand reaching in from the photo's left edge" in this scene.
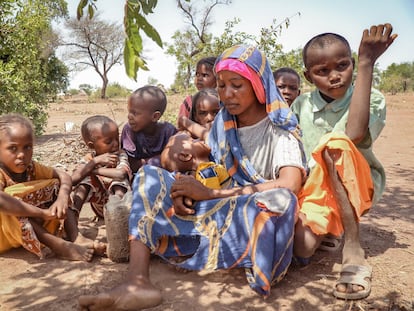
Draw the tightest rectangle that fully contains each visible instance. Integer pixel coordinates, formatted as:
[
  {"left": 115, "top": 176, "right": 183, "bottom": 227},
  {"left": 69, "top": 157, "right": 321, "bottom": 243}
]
[{"left": 0, "top": 191, "right": 56, "bottom": 220}]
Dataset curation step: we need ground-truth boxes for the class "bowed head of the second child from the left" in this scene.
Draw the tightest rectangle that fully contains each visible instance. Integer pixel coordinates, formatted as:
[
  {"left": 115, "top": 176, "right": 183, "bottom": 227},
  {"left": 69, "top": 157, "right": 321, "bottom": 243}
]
[{"left": 81, "top": 115, "right": 119, "bottom": 155}]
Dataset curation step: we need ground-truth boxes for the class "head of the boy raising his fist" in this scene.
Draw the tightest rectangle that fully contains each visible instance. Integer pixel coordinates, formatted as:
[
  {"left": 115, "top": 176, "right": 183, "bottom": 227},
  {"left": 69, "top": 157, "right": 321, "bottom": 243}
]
[{"left": 303, "top": 33, "right": 355, "bottom": 102}]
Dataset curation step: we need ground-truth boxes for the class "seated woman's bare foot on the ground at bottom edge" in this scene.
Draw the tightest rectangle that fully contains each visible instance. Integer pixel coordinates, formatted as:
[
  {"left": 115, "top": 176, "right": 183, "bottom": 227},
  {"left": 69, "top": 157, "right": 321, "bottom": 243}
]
[{"left": 79, "top": 278, "right": 162, "bottom": 311}]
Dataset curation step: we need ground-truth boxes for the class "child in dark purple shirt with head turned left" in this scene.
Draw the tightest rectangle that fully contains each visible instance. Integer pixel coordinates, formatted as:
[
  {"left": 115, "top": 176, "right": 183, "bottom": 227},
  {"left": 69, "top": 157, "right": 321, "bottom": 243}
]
[{"left": 121, "top": 85, "right": 177, "bottom": 173}]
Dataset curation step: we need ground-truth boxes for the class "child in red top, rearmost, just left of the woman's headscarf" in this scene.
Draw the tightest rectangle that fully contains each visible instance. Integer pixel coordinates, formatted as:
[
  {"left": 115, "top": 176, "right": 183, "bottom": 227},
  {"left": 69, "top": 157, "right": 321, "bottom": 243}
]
[{"left": 177, "top": 57, "right": 217, "bottom": 119}]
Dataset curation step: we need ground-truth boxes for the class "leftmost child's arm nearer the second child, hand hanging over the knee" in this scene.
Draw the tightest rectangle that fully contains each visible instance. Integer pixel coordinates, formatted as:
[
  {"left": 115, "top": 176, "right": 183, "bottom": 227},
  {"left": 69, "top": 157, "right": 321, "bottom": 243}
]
[{"left": 50, "top": 169, "right": 72, "bottom": 219}]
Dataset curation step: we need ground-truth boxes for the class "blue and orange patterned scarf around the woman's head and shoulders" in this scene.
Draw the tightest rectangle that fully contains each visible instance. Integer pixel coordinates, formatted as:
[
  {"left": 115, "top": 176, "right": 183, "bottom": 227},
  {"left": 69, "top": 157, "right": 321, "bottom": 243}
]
[{"left": 212, "top": 45, "right": 307, "bottom": 185}]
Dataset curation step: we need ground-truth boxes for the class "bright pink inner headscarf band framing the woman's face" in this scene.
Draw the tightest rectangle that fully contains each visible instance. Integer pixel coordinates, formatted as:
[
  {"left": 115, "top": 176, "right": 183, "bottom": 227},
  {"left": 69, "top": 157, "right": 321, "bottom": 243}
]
[{"left": 215, "top": 58, "right": 266, "bottom": 104}]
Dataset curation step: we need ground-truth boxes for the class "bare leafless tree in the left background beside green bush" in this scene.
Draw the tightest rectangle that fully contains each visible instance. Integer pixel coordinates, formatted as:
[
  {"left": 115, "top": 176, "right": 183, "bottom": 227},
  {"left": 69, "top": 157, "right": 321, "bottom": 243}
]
[{"left": 63, "top": 15, "right": 125, "bottom": 98}]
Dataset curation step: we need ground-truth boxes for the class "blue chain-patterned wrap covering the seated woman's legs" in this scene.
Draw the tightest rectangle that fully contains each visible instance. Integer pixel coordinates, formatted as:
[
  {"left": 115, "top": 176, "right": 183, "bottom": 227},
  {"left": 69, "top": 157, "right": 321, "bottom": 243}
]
[{"left": 129, "top": 165, "right": 297, "bottom": 296}]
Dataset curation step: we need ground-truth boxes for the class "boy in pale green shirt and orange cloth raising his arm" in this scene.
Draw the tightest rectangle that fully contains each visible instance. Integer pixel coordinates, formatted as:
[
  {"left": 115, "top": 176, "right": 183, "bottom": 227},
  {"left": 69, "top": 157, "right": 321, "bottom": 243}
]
[{"left": 292, "top": 24, "right": 397, "bottom": 299}]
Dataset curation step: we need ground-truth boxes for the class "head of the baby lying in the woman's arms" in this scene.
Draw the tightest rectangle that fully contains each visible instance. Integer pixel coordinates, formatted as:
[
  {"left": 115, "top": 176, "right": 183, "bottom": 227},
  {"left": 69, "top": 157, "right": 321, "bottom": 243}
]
[{"left": 161, "top": 132, "right": 210, "bottom": 173}]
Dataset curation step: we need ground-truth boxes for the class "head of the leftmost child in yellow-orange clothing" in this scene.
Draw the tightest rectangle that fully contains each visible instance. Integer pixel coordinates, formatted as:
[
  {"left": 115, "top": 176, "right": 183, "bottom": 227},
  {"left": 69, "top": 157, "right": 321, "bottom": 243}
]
[{"left": 0, "top": 113, "right": 34, "bottom": 174}]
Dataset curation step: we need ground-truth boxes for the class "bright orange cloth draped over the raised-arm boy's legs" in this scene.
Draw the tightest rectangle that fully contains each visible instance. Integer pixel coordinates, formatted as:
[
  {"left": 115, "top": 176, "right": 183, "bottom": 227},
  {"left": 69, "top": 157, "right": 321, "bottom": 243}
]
[{"left": 298, "top": 133, "right": 374, "bottom": 236}]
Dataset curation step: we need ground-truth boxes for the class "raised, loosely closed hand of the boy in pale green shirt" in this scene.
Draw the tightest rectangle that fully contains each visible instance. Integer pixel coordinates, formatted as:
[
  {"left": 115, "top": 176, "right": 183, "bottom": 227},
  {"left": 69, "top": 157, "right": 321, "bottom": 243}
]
[{"left": 358, "top": 23, "right": 398, "bottom": 66}]
